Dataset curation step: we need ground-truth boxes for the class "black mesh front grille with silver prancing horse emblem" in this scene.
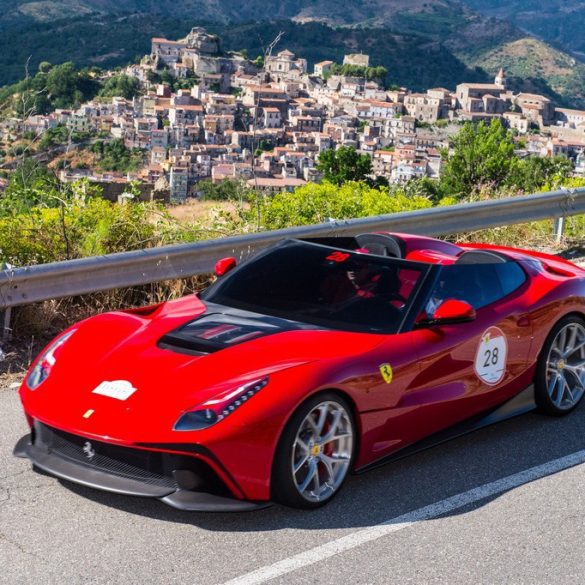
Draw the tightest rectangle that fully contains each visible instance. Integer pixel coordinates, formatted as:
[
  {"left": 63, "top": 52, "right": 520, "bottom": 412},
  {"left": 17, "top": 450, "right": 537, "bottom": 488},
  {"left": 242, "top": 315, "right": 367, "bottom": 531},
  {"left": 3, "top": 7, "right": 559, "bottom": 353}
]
[{"left": 35, "top": 421, "right": 177, "bottom": 488}]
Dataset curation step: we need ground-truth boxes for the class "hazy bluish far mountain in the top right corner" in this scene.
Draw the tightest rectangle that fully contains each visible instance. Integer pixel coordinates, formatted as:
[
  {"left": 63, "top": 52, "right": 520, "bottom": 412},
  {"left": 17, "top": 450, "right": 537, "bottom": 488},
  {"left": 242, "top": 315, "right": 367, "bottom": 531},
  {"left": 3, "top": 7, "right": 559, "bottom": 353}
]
[{"left": 465, "top": 0, "right": 585, "bottom": 60}]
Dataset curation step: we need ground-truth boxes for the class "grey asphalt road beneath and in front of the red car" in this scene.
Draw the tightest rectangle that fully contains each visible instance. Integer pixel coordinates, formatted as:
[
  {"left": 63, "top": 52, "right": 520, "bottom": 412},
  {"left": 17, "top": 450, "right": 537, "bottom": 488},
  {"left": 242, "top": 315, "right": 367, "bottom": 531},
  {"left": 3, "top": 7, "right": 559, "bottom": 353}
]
[{"left": 0, "top": 389, "right": 585, "bottom": 585}]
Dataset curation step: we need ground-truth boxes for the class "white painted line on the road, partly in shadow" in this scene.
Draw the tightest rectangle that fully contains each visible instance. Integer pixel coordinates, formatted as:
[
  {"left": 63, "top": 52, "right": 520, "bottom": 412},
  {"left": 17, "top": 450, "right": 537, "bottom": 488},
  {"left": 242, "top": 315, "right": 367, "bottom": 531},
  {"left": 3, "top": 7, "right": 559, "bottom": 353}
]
[{"left": 224, "top": 450, "right": 585, "bottom": 585}]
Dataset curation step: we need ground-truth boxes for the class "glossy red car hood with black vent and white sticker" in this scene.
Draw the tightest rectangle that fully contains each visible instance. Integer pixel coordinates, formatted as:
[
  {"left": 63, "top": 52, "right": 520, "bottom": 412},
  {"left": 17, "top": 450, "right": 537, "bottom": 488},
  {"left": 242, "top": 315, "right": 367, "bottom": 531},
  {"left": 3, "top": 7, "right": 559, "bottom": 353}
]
[{"left": 21, "top": 296, "right": 382, "bottom": 442}]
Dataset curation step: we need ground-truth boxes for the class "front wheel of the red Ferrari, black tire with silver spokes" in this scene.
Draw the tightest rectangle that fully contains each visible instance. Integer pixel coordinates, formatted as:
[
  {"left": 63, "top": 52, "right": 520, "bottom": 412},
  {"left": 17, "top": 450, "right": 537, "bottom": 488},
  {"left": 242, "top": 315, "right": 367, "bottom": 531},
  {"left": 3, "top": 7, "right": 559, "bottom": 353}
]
[{"left": 271, "top": 392, "right": 357, "bottom": 509}]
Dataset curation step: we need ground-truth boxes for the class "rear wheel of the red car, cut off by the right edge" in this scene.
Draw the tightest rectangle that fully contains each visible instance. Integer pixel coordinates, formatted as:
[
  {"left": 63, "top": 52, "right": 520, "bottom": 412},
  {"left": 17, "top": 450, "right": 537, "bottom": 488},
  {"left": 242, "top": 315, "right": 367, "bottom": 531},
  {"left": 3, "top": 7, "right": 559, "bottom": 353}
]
[{"left": 534, "top": 315, "right": 585, "bottom": 416}]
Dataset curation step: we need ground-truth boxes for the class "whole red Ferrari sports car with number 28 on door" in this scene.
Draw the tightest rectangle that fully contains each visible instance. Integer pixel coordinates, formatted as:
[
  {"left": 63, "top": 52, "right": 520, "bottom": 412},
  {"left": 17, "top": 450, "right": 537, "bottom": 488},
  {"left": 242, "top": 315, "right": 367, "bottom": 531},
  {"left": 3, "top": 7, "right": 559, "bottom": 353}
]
[{"left": 15, "top": 233, "right": 585, "bottom": 510}]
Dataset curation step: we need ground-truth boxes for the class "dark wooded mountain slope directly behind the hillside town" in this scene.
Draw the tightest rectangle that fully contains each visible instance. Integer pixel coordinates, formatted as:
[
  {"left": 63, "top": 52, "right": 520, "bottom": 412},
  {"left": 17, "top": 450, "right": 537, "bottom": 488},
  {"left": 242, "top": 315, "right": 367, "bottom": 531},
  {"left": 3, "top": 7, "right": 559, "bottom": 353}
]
[{"left": 0, "top": 0, "right": 585, "bottom": 107}]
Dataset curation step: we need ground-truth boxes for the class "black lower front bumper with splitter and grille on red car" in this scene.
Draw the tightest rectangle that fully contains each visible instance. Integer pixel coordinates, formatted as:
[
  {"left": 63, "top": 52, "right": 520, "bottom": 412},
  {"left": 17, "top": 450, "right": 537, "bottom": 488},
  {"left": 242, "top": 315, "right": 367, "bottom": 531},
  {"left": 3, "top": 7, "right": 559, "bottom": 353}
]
[{"left": 14, "top": 421, "right": 270, "bottom": 512}]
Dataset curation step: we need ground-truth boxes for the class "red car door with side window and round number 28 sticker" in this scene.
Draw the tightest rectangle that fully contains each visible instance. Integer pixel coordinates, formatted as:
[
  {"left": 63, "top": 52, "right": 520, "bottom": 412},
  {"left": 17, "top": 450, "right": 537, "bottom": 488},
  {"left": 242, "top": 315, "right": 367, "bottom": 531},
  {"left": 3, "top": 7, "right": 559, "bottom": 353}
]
[{"left": 368, "top": 262, "right": 532, "bottom": 450}]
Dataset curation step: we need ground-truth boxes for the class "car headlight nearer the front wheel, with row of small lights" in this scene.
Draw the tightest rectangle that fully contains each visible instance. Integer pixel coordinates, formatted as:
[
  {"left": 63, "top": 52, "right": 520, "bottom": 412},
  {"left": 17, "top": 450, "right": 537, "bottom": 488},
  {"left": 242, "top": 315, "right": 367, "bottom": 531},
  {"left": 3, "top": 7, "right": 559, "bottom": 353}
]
[{"left": 173, "top": 377, "right": 268, "bottom": 431}]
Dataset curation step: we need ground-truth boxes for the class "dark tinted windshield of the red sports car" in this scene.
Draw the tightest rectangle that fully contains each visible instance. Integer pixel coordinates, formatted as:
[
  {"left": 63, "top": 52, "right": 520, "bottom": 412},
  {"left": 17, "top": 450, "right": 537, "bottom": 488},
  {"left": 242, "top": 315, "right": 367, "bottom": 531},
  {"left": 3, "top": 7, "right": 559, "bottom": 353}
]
[{"left": 203, "top": 240, "right": 428, "bottom": 333}]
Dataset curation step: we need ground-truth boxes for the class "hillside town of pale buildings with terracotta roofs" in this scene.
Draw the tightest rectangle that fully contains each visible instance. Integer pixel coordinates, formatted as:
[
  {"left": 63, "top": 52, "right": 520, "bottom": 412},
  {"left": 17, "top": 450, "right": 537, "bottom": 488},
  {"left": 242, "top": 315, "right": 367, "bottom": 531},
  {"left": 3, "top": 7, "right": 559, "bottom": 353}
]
[{"left": 0, "top": 28, "right": 585, "bottom": 202}]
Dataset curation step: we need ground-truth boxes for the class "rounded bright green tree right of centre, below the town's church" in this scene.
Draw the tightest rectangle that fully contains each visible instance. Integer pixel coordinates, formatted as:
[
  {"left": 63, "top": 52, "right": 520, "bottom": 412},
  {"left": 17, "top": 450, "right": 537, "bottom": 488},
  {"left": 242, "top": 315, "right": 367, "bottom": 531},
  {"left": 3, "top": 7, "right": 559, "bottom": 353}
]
[{"left": 441, "top": 119, "right": 518, "bottom": 197}]
